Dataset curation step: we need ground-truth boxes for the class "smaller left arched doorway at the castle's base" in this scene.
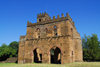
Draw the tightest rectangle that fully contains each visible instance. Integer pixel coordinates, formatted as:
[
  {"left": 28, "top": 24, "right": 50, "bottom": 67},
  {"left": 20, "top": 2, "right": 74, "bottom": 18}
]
[{"left": 33, "top": 48, "right": 42, "bottom": 63}]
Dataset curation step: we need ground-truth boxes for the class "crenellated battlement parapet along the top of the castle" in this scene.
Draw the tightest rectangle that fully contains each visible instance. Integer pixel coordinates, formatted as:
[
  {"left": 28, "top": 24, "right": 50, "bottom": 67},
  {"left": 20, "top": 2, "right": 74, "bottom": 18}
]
[{"left": 27, "top": 12, "right": 74, "bottom": 26}]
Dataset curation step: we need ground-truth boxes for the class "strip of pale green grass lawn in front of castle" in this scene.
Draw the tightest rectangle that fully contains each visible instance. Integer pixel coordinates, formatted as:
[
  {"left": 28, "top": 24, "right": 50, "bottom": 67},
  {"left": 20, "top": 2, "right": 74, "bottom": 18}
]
[{"left": 0, "top": 62, "right": 100, "bottom": 67}]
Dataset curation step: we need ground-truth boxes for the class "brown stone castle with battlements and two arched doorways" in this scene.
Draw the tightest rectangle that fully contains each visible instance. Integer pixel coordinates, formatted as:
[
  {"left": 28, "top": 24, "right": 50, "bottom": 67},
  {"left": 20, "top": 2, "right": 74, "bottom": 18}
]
[{"left": 18, "top": 12, "right": 83, "bottom": 64}]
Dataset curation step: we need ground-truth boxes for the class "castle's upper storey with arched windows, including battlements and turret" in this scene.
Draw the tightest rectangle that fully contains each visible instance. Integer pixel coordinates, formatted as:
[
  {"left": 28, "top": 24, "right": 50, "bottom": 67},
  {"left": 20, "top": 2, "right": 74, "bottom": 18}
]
[{"left": 26, "top": 12, "right": 77, "bottom": 39}]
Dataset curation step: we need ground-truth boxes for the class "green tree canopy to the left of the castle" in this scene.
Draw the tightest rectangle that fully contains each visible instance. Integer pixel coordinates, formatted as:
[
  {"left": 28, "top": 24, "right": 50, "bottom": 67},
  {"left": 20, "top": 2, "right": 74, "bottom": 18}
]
[{"left": 0, "top": 41, "right": 18, "bottom": 61}]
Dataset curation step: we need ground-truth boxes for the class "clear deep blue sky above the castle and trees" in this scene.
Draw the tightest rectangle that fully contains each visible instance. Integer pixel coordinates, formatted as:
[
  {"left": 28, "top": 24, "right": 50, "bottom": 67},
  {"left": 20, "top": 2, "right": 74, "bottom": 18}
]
[{"left": 0, "top": 0, "right": 100, "bottom": 45}]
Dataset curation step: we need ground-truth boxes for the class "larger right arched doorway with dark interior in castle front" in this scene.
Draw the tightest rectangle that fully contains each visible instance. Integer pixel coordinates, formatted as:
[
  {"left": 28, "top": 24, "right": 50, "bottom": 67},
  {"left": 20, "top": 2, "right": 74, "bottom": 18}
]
[{"left": 50, "top": 47, "right": 61, "bottom": 64}]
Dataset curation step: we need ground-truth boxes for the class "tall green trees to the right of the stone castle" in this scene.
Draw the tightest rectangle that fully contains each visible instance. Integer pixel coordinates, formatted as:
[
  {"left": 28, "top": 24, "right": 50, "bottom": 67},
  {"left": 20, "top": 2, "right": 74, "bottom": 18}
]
[{"left": 82, "top": 34, "right": 100, "bottom": 61}]
